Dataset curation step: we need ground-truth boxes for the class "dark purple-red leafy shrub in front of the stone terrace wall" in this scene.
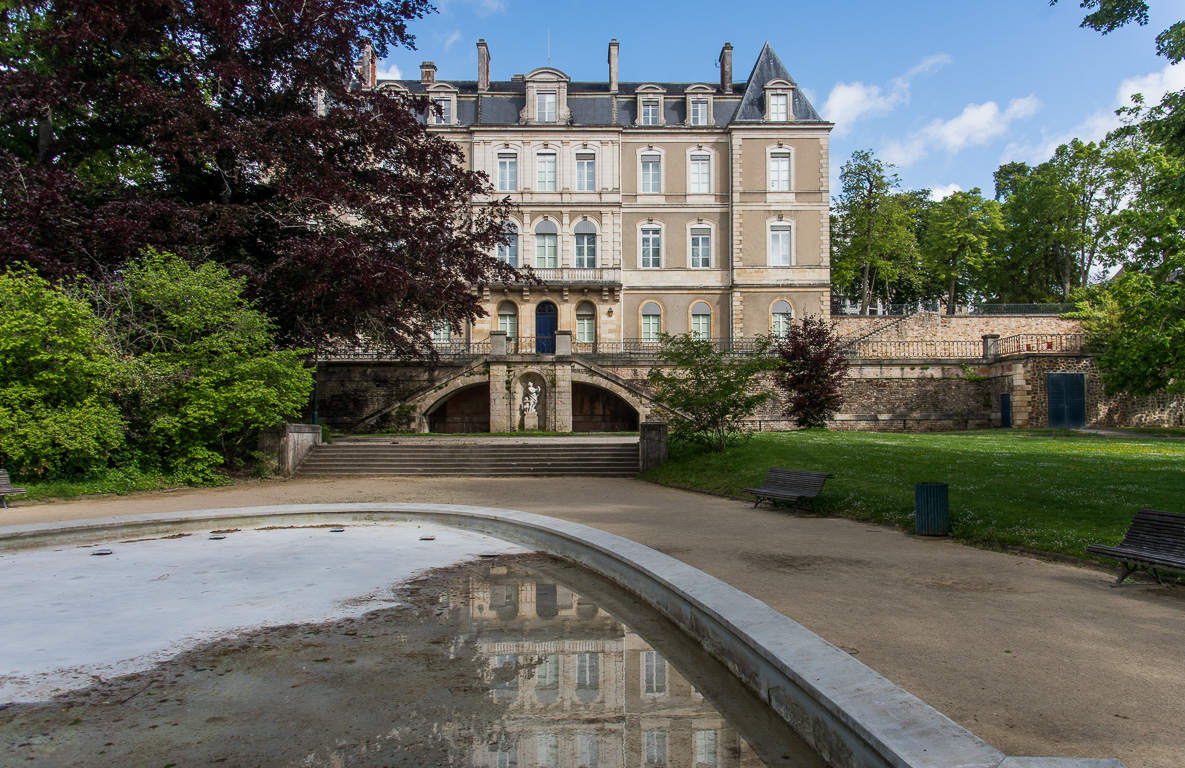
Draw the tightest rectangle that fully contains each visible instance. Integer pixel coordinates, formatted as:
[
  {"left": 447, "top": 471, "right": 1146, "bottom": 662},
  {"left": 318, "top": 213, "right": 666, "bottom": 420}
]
[{"left": 774, "top": 315, "right": 847, "bottom": 428}]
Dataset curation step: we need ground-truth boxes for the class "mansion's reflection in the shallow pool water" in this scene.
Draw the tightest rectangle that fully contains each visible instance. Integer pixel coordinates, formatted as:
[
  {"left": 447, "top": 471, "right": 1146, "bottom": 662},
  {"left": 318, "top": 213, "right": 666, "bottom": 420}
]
[{"left": 449, "top": 567, "right": 764, "bottom": 768}]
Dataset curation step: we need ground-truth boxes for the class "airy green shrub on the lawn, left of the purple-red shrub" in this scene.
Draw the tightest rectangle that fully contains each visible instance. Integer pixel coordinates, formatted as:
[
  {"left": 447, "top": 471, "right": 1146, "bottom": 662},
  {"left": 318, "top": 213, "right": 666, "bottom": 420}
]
[{"left": 646, "top": 333, "right": 773, "bottom": 450}]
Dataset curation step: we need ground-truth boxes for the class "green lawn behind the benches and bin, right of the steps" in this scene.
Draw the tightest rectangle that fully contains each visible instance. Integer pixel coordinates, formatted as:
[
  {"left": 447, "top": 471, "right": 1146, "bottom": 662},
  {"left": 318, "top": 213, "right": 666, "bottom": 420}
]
[{"left": 646, "top": 430, "right": 1185, "bottom": 557}]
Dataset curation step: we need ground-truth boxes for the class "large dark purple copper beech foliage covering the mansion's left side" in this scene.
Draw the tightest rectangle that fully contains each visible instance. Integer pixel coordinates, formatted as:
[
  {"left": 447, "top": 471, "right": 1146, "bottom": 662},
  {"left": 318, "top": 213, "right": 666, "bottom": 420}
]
[{"left": 0, "top": 0, "right": 517, "bottom": 351}]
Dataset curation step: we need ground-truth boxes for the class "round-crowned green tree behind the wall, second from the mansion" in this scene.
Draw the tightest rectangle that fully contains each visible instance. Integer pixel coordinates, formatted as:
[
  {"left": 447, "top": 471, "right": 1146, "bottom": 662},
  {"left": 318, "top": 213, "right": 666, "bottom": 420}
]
[{"left": 924, "top": 187, "right": 1004, "bottom": 314}]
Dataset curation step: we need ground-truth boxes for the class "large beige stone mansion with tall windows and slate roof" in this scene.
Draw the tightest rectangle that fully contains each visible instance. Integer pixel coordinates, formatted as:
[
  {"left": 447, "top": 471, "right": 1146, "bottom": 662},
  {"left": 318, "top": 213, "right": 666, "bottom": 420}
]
[{"left": 358, "top": 40, "right": 832, "bottom": 353}]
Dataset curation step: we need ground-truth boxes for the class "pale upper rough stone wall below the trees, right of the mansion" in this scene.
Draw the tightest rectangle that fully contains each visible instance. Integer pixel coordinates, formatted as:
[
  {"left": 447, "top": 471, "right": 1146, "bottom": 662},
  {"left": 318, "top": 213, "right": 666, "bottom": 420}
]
[{"left": 833, "top": 312, "right": 1082, "bottom": 341}]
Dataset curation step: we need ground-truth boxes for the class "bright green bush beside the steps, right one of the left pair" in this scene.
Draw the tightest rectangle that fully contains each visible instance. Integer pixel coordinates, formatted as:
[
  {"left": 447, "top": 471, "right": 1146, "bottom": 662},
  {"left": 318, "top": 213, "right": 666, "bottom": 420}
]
[{"left": 96, "top": 251, "right": 313, "bottom": 481}]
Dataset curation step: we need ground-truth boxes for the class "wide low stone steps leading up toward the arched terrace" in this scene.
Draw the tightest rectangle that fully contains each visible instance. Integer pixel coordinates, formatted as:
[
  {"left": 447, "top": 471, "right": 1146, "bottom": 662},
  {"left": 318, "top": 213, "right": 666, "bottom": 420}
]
[{"left": 296, "top": 436, "right": 638, "bottom": 478}]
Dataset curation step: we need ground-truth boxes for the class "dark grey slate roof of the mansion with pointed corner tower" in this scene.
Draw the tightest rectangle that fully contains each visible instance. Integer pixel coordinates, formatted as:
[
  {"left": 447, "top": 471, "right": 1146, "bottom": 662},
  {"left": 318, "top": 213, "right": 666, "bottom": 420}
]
[{"left": 378, "top": 43, "right": 824, "bottom": 127}]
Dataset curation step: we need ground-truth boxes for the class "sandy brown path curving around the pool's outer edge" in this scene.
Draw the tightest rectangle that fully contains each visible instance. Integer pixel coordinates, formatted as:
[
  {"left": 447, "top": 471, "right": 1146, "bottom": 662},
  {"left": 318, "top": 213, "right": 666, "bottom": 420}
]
[{"left": 2, "top": 478, "right": 1185, "bottom": 768}]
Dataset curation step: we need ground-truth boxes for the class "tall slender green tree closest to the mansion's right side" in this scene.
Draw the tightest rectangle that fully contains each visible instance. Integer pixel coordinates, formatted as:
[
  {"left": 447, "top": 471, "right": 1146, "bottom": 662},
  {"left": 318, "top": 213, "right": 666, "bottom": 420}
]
[{"left": 831, "top": 149, "right": 917, "bottom": 314}]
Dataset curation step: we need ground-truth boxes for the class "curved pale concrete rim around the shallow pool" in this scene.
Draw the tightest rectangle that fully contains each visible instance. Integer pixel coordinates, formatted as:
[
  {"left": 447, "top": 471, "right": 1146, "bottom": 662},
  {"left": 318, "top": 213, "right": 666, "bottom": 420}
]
[{"left": 0, "top": 503, "right": 1123, "bottom": 768}]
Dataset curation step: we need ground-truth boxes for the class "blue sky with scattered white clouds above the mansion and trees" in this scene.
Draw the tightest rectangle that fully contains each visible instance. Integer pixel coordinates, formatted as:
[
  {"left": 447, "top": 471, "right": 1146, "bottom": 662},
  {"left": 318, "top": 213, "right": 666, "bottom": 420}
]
[{"left": 380, "top": 0, "right": 1185, "bottom": 201}]
